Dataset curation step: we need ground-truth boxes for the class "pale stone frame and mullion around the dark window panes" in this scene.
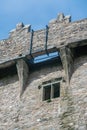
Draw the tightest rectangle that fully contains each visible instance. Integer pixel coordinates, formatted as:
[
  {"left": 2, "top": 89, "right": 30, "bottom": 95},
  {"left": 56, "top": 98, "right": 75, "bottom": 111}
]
[{"left": 42, "top": 78, "right": 62, "bottom": 101}]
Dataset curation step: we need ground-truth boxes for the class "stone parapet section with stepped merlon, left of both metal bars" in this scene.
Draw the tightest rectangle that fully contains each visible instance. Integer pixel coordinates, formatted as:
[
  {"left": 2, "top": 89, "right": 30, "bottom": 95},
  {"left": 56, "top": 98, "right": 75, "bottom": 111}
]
[{"left": 0, "top": 25, "right": 30, "bottom": 64}]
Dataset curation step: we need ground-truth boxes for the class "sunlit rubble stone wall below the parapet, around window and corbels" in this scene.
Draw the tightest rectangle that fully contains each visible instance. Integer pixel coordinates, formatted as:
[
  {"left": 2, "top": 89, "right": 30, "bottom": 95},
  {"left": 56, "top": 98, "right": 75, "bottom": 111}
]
[{"left": 0, "top": 55, "right": 87, "bottom": 130}]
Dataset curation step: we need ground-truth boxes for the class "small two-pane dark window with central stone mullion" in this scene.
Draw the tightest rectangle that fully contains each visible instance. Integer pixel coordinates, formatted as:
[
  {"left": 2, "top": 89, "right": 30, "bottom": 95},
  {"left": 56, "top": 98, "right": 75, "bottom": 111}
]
[{"left": 42, "top": 82, "right": 60, "bottom": 101}]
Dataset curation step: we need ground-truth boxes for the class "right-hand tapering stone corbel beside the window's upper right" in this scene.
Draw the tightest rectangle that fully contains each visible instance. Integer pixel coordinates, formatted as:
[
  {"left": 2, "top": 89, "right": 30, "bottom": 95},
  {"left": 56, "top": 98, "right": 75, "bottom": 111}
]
[{"left": 60, "top": 46, "right": 74, "bottom": 85}]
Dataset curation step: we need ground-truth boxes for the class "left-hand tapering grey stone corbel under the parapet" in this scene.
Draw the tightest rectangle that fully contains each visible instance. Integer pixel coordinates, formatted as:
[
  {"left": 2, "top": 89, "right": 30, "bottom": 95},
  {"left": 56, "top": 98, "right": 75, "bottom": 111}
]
[{"left": 16, "top": 59, "right": 29, "bottom": 97}]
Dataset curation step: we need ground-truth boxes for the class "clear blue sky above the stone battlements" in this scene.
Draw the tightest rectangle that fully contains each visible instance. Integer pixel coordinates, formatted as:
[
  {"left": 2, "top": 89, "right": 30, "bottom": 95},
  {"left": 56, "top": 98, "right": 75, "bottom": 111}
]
[{"left": 0, "top": 0, "right": 87, "bottom": 39}]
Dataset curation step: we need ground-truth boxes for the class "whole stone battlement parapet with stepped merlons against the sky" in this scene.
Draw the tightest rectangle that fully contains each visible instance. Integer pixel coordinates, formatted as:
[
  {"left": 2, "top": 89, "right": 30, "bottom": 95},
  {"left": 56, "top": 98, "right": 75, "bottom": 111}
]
[{"left": 0, "top": 13, "right": 87, "bottom": 64}]
